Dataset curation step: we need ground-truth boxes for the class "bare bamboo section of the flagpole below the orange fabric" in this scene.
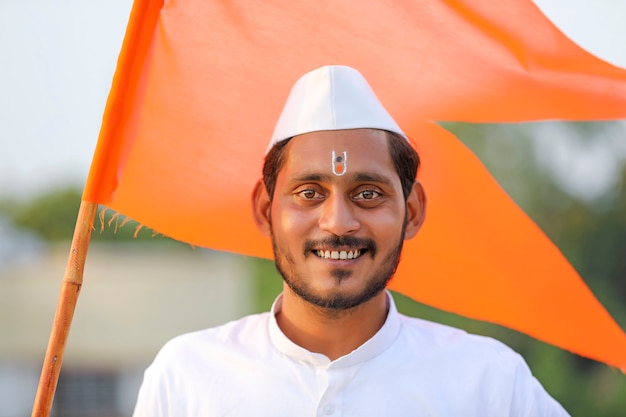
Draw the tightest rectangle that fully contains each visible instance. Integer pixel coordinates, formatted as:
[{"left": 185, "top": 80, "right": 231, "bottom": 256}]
[{"left": 32, "top": 201, "right": 98, "bottom": 417}]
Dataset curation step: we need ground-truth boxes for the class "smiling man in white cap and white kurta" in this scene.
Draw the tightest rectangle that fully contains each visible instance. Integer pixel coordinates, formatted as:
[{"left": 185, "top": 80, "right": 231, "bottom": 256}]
[{"left": 135, "top": 66, "right": 567, "bottom": 417}]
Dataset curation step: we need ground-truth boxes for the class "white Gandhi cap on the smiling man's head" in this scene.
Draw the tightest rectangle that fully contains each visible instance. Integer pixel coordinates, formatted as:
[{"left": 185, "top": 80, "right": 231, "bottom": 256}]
[{"left": 266, "top": 65, "right": 407, "bottom": 152}]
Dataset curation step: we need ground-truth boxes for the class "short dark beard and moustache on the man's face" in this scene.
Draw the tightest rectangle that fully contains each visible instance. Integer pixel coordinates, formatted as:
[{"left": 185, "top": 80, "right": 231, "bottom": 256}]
[{"left": 270, "top": 219, "right": 406, "bottom": 312}]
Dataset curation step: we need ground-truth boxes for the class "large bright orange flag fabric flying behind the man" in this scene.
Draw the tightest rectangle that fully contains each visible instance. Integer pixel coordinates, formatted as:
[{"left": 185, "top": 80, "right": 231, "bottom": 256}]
[{"left": 83, "top": 0, "right": 626, "bottom": 371}]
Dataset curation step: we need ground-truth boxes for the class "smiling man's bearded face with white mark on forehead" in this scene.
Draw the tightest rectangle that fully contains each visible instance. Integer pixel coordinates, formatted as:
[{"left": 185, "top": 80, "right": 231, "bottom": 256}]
[{"left": 255, "top": 129, "right": 422, "bottom": 309}]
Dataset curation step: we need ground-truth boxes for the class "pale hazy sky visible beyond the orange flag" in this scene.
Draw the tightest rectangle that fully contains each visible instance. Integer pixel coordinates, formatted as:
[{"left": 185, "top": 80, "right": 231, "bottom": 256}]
[{"left": 0, "top": 0, "right": 626, "bottom": 197}]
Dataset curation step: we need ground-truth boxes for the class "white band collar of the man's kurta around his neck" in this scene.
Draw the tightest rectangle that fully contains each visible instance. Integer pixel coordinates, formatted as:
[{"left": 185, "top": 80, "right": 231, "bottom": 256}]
[{"left": 269, "top": 291, "right": 401, "bottom": 368}]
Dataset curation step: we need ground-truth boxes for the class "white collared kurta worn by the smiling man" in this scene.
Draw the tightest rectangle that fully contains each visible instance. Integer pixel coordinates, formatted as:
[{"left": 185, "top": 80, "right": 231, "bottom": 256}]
[{"left": 134, "top": 296, "right": 568, "bottom": 417}]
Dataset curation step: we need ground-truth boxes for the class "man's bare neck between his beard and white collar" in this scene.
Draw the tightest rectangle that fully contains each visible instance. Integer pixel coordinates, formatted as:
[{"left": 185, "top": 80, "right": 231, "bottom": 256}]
[{"left": 276, "top": 287, "right": 389, "bottom": 360}]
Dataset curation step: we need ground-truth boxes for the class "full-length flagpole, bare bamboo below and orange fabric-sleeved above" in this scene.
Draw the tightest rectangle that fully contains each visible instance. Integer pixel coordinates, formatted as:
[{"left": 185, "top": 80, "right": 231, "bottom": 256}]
[{"left": 32, "top": 0, "right": 163, "bottom": 417}]
